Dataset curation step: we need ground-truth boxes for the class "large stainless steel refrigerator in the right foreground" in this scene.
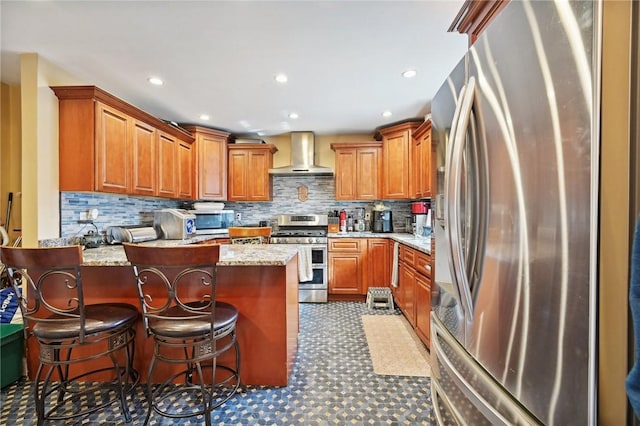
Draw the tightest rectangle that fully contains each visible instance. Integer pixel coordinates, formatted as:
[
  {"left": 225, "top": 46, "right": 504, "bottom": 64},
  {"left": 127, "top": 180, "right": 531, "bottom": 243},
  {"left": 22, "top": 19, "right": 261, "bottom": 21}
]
[{"left": 431, "top": 1, "right": 600, "bottom": 425}]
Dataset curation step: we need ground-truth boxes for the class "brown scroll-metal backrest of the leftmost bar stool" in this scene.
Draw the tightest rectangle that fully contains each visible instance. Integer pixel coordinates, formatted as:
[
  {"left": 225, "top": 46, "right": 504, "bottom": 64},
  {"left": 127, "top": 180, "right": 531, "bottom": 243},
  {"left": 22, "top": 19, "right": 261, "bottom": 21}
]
[{"left": 0, "top": 246, "right": 86, "bottom": 343}]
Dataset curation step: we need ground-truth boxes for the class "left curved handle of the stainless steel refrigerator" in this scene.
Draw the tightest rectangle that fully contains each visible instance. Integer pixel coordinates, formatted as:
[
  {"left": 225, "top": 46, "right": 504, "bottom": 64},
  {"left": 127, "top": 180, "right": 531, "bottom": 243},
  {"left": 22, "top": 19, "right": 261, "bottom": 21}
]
[{"left": 446, "top": 77, "right": 475, "bottom": 321}]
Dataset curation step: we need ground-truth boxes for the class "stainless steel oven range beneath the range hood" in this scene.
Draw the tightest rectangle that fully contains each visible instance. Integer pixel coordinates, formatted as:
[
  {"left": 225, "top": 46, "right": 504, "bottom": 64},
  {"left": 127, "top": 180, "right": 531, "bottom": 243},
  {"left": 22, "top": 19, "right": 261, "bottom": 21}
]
[{"left": 271, "top": 214, "right": 329, "bottom": 303}]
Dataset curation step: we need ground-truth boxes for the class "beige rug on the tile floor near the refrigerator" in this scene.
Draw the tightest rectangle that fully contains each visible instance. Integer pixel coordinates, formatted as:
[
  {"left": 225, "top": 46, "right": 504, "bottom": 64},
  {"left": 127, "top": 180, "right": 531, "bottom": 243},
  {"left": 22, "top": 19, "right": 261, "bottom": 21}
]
[{"left": 362, "top": 315, "right": 431, "bottom": 377}]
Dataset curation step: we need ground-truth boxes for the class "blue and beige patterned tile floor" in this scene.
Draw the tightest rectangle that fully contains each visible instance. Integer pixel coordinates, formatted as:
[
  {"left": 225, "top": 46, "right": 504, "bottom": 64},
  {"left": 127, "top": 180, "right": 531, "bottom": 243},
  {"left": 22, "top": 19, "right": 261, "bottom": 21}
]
[{"left": 0, "top": 302, "right": 436, "bottom": 425}]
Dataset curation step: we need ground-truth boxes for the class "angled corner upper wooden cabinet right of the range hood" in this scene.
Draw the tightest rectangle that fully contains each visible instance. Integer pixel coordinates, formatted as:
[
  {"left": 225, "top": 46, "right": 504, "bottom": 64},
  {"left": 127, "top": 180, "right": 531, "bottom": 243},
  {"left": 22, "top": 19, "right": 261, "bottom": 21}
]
[{"left": 378, "top": 121, "right": 420, "bottom": 200}]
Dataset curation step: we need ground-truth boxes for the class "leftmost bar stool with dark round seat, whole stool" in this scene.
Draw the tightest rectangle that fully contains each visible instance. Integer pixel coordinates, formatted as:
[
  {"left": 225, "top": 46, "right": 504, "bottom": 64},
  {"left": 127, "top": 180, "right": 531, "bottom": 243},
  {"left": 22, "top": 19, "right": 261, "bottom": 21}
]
[{"left": 0, "top": 246, "right": 139, "bottom": 425}]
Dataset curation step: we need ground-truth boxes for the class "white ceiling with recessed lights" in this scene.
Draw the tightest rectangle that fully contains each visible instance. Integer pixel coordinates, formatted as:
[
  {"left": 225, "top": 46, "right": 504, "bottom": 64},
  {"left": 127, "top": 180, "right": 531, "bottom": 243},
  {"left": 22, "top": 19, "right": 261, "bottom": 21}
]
[{"left": 0, "top": 0, "right": 467, "bottom": 135}]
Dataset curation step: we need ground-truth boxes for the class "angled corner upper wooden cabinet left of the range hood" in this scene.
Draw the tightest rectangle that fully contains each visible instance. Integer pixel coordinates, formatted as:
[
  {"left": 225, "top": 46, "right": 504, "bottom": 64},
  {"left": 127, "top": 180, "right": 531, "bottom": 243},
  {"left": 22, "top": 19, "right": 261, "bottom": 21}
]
[{"left": 183, "top": 126, "right": 229, "bottom": 201}]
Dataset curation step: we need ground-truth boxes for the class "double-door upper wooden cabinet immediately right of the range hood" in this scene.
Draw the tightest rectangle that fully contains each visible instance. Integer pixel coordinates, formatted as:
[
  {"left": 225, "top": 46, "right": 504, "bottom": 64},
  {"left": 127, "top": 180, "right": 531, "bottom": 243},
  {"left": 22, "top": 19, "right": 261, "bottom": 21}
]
[{"left": 331, "top": 141, "right": 382, "bottom": 200}]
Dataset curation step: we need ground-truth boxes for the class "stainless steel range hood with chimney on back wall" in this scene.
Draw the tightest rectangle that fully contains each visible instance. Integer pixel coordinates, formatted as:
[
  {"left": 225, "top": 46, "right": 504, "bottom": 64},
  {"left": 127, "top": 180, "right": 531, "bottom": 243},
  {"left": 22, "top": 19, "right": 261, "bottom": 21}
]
[{"left": 269, "top": 132, "right": 333, "bottom": 176}]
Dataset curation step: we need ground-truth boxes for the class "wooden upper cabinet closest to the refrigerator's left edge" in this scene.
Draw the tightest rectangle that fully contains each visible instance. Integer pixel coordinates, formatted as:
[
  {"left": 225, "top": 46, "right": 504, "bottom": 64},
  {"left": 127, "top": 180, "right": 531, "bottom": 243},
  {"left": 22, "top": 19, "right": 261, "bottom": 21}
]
[{"left": 409, "top": 120, "right": 432, "bottom": 199}]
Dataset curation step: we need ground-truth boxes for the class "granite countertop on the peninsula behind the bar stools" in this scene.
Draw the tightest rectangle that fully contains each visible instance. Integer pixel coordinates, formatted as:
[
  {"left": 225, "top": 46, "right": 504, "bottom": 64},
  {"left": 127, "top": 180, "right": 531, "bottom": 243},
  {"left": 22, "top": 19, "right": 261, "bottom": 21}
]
[{"left": 83, "top": 237, "right": 298, "bottom": 266}]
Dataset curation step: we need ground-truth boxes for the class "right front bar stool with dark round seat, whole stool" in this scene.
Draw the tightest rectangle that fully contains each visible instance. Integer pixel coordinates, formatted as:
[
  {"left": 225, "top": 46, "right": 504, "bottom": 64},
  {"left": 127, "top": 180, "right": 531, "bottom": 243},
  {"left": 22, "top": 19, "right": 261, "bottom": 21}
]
[{"left": 124, "top": 244, "right": 240, "bottom": 425}]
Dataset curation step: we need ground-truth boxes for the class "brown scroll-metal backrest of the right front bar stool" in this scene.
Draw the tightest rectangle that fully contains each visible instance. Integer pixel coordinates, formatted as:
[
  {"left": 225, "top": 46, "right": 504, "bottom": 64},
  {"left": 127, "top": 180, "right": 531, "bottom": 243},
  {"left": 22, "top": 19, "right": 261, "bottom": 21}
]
[{"left": 124, "top": 243, "right": 220, "bottom": 336}]
